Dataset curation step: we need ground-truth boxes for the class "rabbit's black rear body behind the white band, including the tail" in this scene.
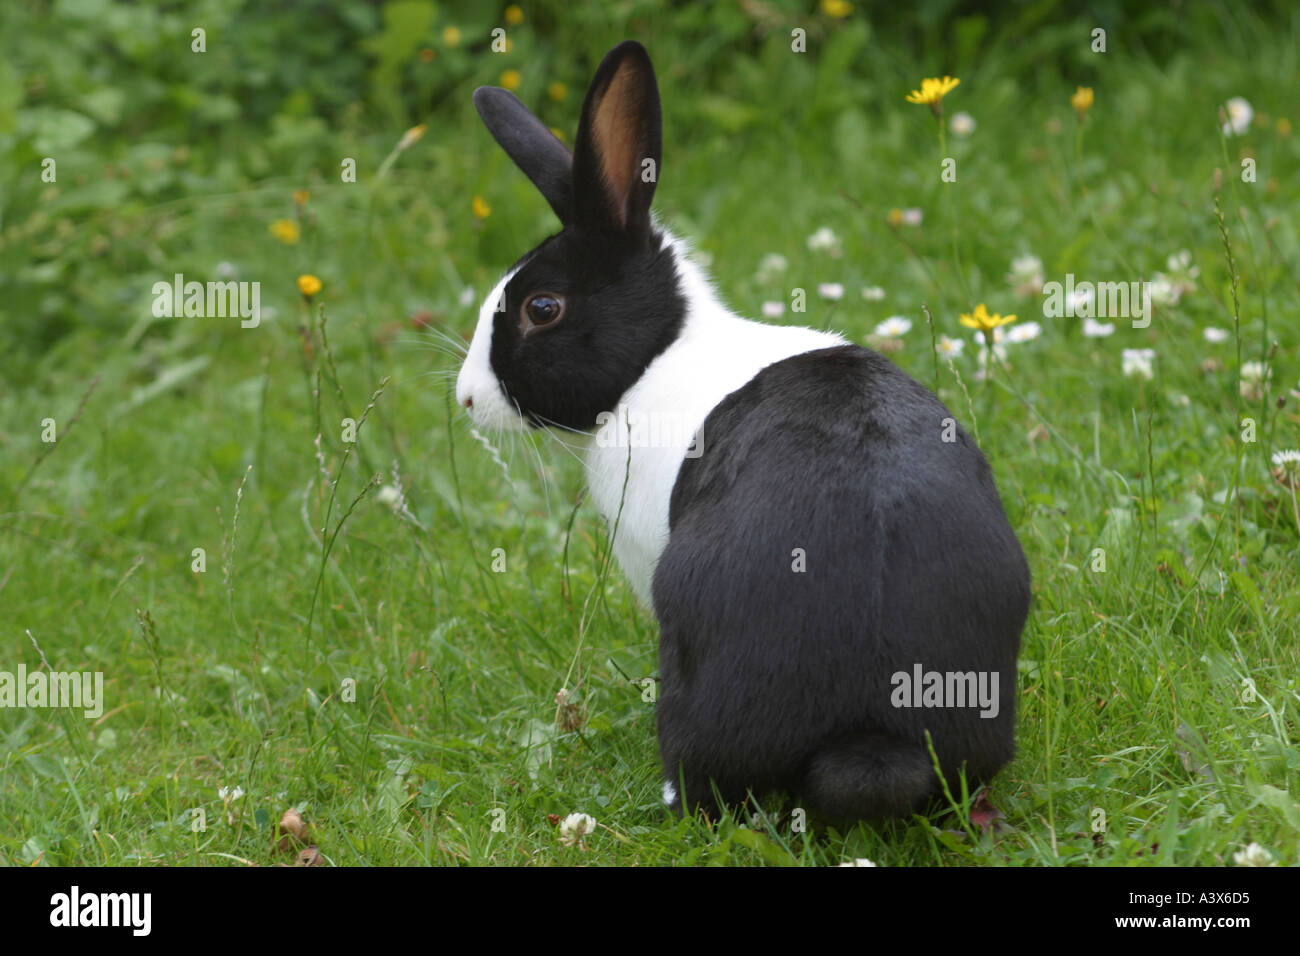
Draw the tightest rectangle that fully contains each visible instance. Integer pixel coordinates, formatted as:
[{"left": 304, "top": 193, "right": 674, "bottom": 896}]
[{"left": 654, "top": 346, "right": 1030, "bottom": 819}]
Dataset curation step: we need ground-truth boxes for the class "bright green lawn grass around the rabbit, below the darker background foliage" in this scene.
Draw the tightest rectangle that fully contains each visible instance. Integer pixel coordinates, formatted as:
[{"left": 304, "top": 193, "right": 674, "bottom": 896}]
[{"left": 0, "top": 3, "right": 1300, "bottom": 866}]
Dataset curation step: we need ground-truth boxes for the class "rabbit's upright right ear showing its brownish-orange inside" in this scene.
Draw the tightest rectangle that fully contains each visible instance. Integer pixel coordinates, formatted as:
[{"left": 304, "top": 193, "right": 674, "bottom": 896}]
[{"left": 573, "top": 40, "right": 663, "bottom": 239}]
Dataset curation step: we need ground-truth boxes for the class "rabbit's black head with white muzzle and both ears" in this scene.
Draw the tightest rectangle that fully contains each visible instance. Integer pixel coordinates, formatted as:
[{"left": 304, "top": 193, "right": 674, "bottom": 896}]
[{"left": 456, "top": 40, "right": 685, "bottom": 429}]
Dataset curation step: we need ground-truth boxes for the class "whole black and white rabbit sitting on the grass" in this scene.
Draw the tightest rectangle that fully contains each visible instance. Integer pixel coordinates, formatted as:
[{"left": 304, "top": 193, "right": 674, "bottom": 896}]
[{"left": 456, "top": 42, "right": 1030, "bottom": 821}]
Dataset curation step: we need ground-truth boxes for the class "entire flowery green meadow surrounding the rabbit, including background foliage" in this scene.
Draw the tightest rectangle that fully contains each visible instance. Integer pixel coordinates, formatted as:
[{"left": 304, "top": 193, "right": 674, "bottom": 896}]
[{"left": 0, "top": 0, "right": 1300, "bottom": 866}]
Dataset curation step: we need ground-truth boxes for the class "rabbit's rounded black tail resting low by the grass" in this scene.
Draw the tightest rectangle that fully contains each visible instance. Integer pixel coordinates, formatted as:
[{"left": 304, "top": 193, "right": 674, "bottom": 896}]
[{"left": 801, "top": 734, "right": 939, "bottom": 821}]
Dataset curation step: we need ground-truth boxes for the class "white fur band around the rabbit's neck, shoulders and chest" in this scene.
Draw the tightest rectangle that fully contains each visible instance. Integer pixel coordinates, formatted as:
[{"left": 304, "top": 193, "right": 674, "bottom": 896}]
[{"left": 584, "top": 250, "right": 846, "bottom": 605}]
